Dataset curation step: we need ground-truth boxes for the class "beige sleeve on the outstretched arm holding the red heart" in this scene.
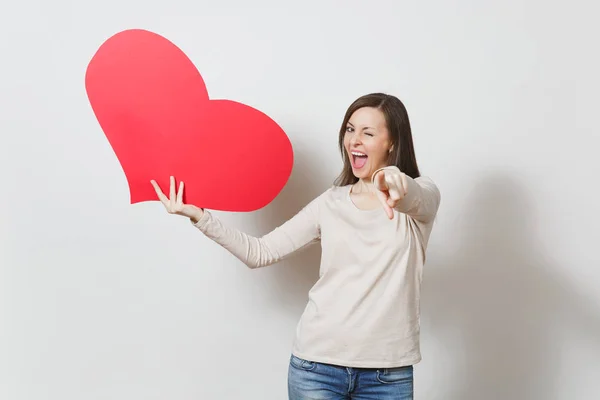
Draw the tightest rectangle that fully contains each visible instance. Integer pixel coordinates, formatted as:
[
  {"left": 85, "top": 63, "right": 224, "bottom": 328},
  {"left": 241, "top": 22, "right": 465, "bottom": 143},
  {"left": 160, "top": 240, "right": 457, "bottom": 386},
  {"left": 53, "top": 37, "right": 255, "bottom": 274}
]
[{"left": 194, "top": 191, "right": 321, "bottom": 268}]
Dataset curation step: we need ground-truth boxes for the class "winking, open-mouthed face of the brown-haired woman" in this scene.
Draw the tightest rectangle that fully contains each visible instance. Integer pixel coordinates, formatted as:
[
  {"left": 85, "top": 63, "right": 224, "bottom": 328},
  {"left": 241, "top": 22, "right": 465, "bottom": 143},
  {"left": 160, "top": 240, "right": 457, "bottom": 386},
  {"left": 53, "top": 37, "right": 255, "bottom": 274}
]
[{"left": 344, "top": 107, "right": 392, "bottom": 181}]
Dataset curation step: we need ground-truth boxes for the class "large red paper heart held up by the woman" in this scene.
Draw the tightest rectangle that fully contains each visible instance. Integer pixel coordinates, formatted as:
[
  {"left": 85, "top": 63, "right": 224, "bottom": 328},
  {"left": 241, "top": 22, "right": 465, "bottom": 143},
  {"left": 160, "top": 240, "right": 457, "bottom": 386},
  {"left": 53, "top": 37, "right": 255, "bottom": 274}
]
[{"left": 85, "top": 29, "right": 293, "bottom": 211}]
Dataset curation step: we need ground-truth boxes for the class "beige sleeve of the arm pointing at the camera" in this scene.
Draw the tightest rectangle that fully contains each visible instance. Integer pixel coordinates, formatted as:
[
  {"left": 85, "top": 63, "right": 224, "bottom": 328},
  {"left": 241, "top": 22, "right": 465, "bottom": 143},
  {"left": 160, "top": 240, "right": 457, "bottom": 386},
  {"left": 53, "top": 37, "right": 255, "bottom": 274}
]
[{"left": 373, "top": 166, "right": 441, "bottom": 223}]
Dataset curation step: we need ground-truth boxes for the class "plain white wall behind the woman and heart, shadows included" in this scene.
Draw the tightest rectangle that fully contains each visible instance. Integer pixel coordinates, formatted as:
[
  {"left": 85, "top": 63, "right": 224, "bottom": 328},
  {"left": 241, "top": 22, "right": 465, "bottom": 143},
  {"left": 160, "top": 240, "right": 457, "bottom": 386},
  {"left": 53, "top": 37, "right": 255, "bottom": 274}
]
[{"left": 0, "top": 0, "right": 600, "bottom": 400}]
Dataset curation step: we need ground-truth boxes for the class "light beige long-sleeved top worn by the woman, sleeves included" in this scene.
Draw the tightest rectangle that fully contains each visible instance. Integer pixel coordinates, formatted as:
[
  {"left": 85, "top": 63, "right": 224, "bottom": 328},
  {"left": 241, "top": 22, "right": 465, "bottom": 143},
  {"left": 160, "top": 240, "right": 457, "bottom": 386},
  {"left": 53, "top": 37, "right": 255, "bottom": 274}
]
[{"left": 195, "top": 169, "right": 440, "bottom": 368}]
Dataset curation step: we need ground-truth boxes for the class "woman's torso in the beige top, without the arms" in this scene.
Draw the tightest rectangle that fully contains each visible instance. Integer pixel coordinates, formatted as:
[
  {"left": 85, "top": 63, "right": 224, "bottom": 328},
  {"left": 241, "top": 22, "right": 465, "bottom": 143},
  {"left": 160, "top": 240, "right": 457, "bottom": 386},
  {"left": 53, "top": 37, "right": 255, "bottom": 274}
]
[{"left": 294, "top": 186, "right": 429, "bottom": 368}]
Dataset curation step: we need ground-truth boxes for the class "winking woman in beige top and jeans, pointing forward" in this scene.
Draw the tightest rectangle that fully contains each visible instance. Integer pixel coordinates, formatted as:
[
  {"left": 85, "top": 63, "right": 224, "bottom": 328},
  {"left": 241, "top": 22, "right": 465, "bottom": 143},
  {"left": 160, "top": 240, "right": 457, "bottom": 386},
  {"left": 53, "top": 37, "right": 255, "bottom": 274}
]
[{"left": 152, "top": 93, "right": 440, "bottom": 400}]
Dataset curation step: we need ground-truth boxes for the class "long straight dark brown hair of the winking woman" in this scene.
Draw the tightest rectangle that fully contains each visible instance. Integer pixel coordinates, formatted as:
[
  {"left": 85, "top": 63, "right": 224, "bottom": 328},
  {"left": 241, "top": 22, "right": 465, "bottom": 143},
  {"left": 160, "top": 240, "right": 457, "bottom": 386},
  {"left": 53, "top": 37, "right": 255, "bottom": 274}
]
[{"left": 334, "top": 93, "right": 421, "bottom": 186}]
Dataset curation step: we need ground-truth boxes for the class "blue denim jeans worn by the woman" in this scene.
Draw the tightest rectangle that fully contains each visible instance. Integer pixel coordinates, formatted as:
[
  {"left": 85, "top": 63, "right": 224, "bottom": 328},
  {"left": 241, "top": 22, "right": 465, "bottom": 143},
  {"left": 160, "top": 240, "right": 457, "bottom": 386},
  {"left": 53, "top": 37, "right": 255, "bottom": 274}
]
[{"left": 288, "top": 355, "right": 413, "bottom": 400}]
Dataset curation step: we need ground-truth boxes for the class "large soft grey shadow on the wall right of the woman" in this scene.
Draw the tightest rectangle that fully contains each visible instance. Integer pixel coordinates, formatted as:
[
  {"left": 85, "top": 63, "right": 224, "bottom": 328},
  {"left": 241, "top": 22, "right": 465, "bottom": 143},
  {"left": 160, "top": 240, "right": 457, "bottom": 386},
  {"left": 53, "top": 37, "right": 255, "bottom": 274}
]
[{"left": 423, "top": 174, "right": 600, "bottom": 400}]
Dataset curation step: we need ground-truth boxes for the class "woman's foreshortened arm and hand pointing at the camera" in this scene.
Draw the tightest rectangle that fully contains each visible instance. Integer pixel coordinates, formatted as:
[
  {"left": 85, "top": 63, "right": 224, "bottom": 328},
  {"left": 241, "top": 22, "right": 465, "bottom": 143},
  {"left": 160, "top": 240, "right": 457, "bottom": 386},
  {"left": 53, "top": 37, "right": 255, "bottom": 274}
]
[{"left": 372, "top": 166, "right": 441, "bottom": 223}]
